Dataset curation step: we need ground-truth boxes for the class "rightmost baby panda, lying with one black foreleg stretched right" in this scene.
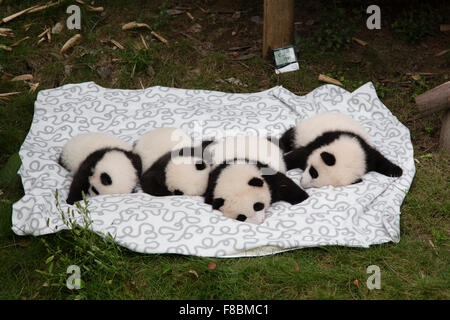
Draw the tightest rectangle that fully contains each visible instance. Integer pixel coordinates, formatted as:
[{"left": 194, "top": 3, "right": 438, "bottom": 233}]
[{"left": 280, "top": 112, "right": 403, "bottom": 188}]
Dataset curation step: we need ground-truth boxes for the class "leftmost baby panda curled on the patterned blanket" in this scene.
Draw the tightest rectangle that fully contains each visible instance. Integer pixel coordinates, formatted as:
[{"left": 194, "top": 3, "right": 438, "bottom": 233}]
[{"left": 59, "top": 132, "right": 142, "bottom": 204}]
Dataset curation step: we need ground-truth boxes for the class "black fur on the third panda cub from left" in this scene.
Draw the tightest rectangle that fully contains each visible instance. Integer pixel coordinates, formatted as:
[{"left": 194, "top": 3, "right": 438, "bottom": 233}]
[{"left": 204, "top": 159, "right": 308, "bottom": 211}]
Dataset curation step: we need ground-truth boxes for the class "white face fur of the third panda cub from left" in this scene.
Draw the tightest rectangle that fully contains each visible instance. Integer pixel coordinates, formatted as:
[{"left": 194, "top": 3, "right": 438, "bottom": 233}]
[{"left": 214, "top": 164, "right": 271, "bottom": 224}]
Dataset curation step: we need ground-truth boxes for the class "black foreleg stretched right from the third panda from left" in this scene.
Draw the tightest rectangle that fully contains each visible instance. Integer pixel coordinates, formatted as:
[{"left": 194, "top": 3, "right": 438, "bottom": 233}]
[{"left": 263, "top": 172, "right": 309, "bottom": 204}]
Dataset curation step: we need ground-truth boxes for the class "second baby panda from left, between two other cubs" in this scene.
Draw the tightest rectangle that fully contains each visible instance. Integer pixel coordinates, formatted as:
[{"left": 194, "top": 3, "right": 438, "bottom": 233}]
[{"left": 134, "top": 128, "right": 210, "bottom": 196}]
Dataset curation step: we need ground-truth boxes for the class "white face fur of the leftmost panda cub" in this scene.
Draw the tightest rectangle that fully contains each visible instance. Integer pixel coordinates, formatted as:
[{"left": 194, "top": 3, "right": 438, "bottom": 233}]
[{"left": 89, "top": 150, "right": 138, "bottom": 196}]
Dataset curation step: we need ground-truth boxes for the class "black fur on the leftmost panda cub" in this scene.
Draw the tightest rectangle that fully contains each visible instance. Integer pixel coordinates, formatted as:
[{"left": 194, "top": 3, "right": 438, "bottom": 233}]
[{"left": 66, "top": 148, "right": 142, "bottom": 204}]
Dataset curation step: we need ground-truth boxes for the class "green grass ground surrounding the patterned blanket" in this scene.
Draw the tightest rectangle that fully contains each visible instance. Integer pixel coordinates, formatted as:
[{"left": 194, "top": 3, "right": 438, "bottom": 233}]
[{"left": 0, "top": 0, "right": 450, "bottom": 299}]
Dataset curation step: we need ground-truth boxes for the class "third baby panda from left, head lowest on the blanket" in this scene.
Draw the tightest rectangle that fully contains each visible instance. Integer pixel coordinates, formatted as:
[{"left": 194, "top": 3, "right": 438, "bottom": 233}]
[{"left": 204, "top": 136, "right": 308, "bottom": 224}]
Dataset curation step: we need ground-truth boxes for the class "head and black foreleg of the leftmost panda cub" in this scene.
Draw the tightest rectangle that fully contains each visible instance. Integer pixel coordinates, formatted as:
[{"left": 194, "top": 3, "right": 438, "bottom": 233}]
[{"left": 67, "top": 148, "right": 142, "bottom": 204}]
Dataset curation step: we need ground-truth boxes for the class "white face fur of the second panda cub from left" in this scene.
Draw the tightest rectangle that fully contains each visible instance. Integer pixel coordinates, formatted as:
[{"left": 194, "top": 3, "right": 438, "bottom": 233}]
[{"left": 166, "top": 157, "right": 211, "bottom": 196}]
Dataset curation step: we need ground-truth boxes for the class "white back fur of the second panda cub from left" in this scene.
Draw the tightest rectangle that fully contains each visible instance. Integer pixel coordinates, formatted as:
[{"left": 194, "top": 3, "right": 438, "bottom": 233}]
[{"left": 134, "top": 128, "right": 193, "bottom": 172}]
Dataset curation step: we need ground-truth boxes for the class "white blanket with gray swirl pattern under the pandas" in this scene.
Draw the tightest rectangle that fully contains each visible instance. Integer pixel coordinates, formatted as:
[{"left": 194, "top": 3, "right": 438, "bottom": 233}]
[{"left": 12, "top": 82, "right": 415, "bottom": 257}]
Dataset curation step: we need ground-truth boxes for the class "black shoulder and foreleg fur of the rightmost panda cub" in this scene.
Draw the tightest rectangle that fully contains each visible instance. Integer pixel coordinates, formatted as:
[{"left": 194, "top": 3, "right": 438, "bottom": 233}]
[{"left": 284, "top": 131, "right": 403, "bottom": 177}]
